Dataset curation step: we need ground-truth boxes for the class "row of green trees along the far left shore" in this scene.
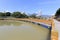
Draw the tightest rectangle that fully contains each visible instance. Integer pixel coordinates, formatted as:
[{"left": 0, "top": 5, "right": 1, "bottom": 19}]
[{"left": 0, "top": 12, "right": 36, "bottom": 18}]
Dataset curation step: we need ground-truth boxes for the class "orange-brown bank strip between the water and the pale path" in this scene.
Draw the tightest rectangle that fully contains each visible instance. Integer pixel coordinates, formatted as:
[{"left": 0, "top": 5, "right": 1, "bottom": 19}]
[{"left": 51, "top": 20, "right": 58, "bottom": 40}]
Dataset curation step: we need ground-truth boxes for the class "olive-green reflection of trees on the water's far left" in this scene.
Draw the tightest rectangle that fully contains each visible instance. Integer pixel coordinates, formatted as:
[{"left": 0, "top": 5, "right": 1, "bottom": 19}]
[{"left": 0, "top": 20, "right": 22, "bottom": 26}]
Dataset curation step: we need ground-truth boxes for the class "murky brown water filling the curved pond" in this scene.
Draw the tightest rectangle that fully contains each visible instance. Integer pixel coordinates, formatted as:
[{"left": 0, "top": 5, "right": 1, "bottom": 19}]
[{"left": 0, "top": 20, "right": 49, "bottom": 40}]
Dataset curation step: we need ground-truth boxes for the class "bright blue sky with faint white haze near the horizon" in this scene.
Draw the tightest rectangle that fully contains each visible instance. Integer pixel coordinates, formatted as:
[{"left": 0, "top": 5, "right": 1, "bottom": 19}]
[{"left": 0, "top": 0, "right": 60, "bottom": 15}]
